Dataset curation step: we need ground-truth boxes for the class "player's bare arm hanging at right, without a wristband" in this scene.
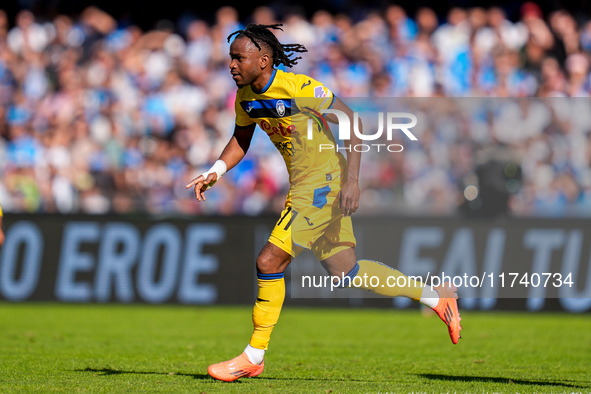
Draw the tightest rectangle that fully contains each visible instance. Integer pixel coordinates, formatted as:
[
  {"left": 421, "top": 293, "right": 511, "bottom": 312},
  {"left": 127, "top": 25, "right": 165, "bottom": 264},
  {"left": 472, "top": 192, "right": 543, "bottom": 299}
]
[{"left": 325, "top": 96, "right": 363, "bottom": 216}]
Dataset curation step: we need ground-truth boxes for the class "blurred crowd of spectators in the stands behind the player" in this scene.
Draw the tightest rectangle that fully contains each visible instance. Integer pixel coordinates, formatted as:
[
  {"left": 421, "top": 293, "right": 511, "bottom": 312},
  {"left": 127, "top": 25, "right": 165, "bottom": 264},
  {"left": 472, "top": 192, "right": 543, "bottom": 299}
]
[{"left": 0, "top": 2, "right": 591, "bottom": 216}]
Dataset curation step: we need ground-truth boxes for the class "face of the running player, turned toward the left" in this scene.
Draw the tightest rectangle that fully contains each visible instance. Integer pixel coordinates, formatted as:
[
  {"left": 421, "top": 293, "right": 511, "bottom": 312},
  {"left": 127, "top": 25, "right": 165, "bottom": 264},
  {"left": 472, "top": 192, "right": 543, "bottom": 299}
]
[{"left": 230, "top": 37, "right": 261, "bottom": 87}]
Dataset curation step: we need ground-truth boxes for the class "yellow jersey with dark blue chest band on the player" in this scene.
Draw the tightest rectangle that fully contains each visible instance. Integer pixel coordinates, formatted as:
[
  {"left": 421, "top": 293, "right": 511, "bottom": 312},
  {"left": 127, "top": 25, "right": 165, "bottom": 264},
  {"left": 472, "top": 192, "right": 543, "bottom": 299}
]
[{"left": 235, "top": 70, "right": 345, "bottom": 189}]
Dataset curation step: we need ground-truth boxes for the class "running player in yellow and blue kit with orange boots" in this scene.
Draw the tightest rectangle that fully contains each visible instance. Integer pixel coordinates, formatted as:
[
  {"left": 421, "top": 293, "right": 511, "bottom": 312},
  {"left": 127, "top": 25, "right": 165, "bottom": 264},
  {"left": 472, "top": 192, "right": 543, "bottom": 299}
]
[{"left": 187, "top": 24, "right": 461, "bottom": 381}]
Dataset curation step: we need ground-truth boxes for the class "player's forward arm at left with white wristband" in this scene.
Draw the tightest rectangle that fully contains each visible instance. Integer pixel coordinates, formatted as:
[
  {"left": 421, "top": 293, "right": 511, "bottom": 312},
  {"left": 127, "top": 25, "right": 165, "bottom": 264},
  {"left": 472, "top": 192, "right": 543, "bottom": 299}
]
[{"left": 186, "top": 123, "right": 256, "bottom": 201}]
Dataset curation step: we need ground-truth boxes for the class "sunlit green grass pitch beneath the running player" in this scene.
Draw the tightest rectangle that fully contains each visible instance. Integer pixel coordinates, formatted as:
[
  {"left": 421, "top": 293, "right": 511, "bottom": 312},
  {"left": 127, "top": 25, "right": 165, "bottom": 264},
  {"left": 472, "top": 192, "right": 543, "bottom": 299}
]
[{"left": 0, "top": 303, "right": 591, "bottom": 393}]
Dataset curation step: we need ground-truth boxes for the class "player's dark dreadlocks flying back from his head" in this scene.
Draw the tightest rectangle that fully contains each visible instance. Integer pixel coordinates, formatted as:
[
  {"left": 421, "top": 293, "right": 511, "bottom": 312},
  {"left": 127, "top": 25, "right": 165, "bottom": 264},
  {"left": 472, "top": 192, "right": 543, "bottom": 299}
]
[{"left": 228, "top": 23, "right": 308, "bottom": 67}]
